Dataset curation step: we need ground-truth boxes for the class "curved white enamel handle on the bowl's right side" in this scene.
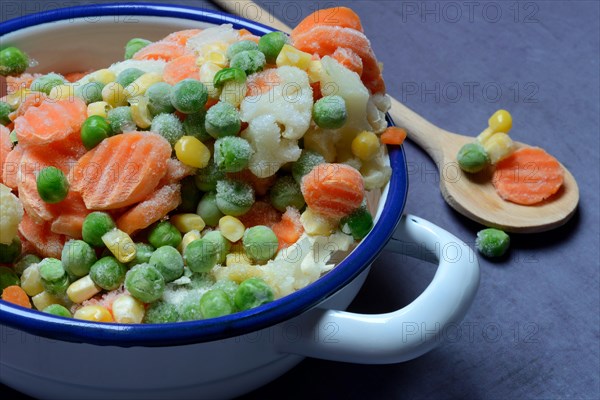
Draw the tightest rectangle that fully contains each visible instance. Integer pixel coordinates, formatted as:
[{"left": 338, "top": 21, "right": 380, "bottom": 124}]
[{"left": 276, "top": 215, "right": 479, "bottom": 364}]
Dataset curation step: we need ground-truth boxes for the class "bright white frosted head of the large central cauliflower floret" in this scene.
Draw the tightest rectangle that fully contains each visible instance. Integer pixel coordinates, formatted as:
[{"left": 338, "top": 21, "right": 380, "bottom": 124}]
[{"left": 240, "top": 66, "right": 313, "bottom": 140}]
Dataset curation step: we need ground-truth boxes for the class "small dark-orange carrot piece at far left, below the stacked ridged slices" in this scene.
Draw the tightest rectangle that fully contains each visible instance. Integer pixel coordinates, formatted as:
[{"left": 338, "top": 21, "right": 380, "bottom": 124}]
[{"left": 19, "top": 213, "right": 66, "bottom": 258}]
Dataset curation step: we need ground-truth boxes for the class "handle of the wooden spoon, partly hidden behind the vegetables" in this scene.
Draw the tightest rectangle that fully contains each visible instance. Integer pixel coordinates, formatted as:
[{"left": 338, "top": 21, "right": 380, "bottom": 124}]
[{"left": 213, "top": 0, "right": 446, "bottom": 162}]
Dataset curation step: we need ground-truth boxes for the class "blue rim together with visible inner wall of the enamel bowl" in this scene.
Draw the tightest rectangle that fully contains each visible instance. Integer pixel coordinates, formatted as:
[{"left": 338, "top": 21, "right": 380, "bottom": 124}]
[{"left": 0, "top": 4, "right": 407, "bottom": 346}]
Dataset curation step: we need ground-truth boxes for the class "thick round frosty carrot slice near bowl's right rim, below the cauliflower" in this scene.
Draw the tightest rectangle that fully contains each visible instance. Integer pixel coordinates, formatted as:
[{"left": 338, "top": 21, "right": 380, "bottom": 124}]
[{"left": 300, "top": 163, "right": 365, "bottom": 218}]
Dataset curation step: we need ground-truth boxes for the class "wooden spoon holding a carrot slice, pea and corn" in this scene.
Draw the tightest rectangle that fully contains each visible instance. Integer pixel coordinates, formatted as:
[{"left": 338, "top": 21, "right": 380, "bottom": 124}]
[{"left": 213, "top": 0, "right": 579, "bottom": 233}]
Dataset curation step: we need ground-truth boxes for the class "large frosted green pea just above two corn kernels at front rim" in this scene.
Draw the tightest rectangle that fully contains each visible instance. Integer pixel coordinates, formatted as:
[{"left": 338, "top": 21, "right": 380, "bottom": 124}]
[{"left": 125, "top": 264, "right": 165, "bottom": 303}]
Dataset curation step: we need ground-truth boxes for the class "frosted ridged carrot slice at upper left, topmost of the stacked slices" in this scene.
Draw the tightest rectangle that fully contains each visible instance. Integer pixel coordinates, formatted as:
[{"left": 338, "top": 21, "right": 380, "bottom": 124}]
[{"left": 15, "top": 97, "right": 87, "bottom": 146}]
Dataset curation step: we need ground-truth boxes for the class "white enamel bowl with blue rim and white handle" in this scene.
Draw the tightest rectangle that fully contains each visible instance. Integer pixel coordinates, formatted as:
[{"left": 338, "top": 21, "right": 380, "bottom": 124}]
[{"left": 0, "top": 4, "right": 479, "bottom": 399}]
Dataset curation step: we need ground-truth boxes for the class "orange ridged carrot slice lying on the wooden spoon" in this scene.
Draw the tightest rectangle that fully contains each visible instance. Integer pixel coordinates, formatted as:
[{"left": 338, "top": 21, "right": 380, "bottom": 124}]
[{"left": 492, "top": 147, "right": 564, "bottom": 205}]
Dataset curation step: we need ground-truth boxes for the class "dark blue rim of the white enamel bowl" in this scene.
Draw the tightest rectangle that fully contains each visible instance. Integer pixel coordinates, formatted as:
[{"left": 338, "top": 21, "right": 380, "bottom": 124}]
[{"left": 0, "top": 3, "right": 408, "bottom": 347}]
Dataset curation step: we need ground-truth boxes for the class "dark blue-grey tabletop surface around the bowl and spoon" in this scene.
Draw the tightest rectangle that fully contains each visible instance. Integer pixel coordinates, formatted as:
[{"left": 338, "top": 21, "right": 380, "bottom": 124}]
[{"left": 0, "top": 0, "right": 600, "bottom": 399}]
